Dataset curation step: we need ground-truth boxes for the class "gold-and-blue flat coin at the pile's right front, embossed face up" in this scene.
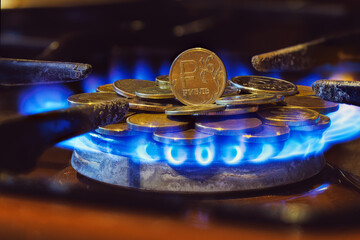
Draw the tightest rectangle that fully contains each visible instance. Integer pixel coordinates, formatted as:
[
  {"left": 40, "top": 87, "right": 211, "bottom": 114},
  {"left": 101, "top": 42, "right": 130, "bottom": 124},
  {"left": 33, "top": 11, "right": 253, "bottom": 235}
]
[{"left": 257, "top": 107, "right": 319, "bottom": 127}]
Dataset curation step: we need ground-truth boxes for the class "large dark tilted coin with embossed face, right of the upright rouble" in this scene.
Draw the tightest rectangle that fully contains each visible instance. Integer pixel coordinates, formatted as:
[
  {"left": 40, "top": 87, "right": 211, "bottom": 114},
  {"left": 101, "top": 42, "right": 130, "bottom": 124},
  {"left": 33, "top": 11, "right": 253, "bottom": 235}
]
[{"left": 230, "top": 76, "right": 297, "bottom": 96}]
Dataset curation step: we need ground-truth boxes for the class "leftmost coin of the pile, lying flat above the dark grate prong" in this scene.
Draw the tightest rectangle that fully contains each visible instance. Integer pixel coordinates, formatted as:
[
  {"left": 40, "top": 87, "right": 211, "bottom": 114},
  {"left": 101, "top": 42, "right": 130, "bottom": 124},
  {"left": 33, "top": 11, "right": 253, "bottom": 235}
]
[{"left": 67, "top": 92, "right": 124, "bottom": 105}]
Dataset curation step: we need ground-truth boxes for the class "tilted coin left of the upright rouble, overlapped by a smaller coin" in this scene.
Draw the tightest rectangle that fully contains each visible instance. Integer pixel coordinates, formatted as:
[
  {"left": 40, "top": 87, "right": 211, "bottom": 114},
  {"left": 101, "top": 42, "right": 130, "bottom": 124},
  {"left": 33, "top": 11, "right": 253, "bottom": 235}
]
[{"left": 113, "top": 79, "right": 156, "bottom": 98}]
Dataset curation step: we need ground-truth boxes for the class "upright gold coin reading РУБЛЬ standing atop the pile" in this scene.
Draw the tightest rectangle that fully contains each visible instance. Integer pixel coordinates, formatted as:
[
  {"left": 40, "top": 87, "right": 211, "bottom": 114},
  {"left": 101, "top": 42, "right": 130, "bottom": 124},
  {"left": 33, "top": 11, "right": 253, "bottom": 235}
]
[{"left": 169, "top": 48, "right": 227, "bottom": 105}]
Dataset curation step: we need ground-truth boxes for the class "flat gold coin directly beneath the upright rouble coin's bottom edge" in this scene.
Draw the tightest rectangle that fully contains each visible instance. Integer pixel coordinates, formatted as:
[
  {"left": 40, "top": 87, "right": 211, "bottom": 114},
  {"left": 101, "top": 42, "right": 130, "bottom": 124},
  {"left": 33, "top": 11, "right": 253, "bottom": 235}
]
[{"left": 165, "top": 104, "right": 225, "bottom": 115}]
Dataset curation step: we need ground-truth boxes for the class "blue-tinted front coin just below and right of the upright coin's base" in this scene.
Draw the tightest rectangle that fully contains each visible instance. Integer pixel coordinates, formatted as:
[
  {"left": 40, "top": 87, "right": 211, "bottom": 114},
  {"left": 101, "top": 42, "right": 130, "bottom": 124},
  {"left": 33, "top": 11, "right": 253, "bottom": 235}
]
[{"left": 195, "top": 118, "right": 262, "bottom": 136}]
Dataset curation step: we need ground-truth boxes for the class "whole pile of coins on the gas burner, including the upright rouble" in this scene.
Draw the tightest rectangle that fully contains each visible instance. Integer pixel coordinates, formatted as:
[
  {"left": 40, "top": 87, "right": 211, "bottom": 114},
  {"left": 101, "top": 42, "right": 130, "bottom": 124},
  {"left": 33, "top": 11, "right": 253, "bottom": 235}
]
[{"left": 68, "top": 48, "right": 338, "bottom": 148}]
